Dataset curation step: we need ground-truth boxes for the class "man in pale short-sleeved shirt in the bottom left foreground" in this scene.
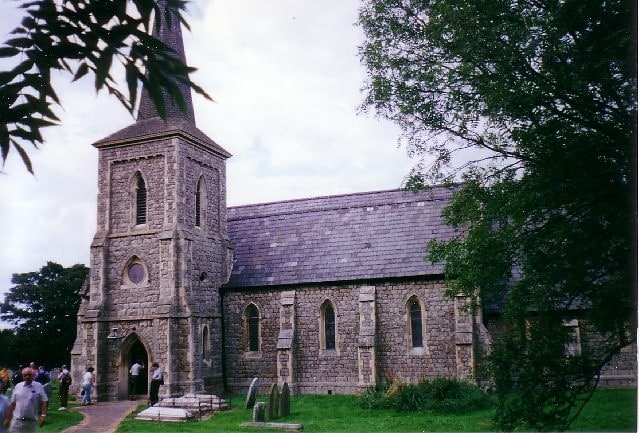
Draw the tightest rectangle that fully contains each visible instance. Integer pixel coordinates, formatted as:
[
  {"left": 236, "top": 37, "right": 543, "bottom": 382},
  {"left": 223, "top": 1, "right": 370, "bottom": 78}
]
[{"left": 3, "top": 368, "right": 47, "bottom": 433}]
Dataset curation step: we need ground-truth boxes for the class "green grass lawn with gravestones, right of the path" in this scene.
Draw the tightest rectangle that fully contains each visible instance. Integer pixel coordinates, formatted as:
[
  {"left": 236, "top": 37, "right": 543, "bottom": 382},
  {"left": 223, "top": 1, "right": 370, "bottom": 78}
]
[{"left": 117, "top": 389, "right": 637, "bottom": 433}]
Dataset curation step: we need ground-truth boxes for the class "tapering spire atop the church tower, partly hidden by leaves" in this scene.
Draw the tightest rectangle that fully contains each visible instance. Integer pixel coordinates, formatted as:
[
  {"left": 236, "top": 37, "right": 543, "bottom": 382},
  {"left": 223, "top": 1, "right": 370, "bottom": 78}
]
[{"left": 136, "top": 0, "right": 196, "bottom": 125}]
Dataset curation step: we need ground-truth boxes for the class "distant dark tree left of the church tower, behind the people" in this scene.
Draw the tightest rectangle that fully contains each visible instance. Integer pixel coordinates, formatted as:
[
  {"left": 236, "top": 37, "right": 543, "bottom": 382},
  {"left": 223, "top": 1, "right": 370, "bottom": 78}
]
[{"left": 0, "top": 262, "right": 89, "bottom": 366}]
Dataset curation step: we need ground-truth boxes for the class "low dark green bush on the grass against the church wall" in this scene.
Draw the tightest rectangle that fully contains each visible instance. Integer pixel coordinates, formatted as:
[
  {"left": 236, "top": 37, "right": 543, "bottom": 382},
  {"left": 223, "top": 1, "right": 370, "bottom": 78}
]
[{"left": 359, "top": 378, "right": 493, "bottom": 414}]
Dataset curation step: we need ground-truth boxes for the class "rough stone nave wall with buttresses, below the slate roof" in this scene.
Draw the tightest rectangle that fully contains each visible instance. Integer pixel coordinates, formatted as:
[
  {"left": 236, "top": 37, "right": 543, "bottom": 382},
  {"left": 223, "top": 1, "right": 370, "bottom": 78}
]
[{"left": 223, "top": 281, "right": 473, "bottom": 394}]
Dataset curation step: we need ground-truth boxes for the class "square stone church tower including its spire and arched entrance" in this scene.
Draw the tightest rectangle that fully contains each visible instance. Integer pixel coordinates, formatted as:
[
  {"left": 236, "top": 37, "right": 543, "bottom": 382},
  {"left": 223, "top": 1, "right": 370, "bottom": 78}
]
[{"left": 72, "top": 2, "right": 232, "bottom": 400}]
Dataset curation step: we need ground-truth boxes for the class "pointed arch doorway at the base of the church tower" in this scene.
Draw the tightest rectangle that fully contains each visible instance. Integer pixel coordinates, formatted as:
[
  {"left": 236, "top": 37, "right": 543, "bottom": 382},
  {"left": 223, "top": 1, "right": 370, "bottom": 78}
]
[{"left": 118, "top": 333, "right": 149, "bottom": 400}]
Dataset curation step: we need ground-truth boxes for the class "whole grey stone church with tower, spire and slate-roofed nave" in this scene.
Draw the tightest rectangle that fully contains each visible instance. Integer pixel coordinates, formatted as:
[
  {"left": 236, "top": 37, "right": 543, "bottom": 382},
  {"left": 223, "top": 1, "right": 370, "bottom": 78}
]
[{"left": 72, "top": 5, "right": 636, "bottom": 400}]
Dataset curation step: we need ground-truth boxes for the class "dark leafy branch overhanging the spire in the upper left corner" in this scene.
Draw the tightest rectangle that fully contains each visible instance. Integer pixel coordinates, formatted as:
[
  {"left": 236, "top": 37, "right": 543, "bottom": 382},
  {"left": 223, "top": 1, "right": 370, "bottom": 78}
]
[{"left": 0, "top": 0, "right": 210, "bottom": 173}]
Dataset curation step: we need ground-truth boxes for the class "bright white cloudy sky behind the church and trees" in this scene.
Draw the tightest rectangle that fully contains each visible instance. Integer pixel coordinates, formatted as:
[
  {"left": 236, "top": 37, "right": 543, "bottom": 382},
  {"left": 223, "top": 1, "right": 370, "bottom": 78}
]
[{"left": 0, "top": 0, "right": 412, "bottom": 302}]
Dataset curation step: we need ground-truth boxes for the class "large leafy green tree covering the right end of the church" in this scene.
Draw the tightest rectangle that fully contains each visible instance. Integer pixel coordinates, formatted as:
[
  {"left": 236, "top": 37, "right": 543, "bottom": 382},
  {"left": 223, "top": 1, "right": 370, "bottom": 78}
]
[{"left": 360, "top": 0, "right": 637, "bottom": 430}]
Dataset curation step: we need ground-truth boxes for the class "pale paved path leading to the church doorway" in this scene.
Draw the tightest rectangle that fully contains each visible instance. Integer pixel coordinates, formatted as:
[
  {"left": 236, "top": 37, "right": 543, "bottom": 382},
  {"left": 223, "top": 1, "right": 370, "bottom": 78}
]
[{"left": 62, "top": 400, "right": 144, "bottom": 433}]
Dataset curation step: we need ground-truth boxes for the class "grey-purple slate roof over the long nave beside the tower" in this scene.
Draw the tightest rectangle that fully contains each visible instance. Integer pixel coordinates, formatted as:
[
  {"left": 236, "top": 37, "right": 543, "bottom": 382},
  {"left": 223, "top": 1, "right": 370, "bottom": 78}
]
[{"left": 226, "top": 188, "right": 455, "bottom": 288}]
